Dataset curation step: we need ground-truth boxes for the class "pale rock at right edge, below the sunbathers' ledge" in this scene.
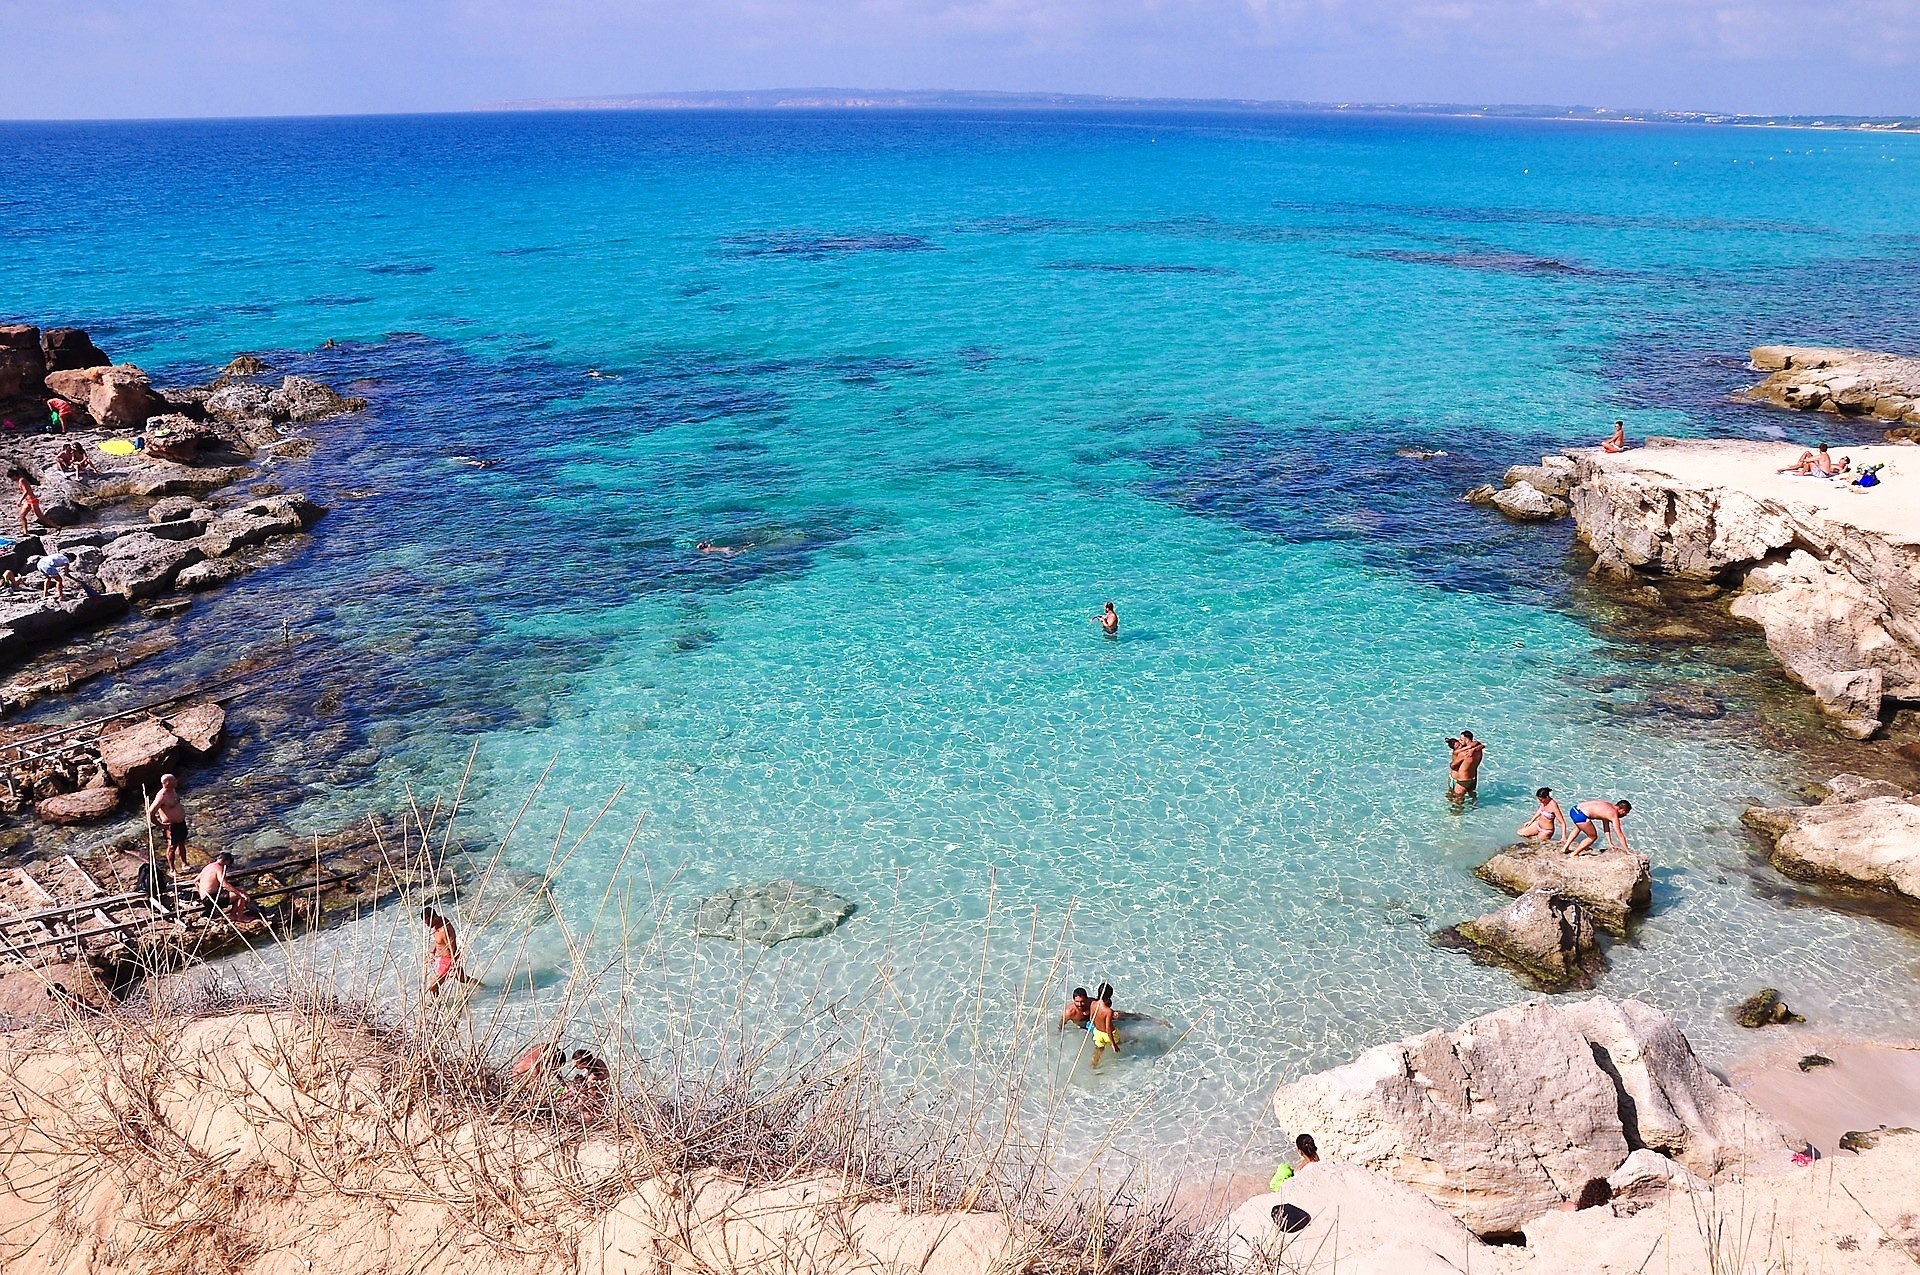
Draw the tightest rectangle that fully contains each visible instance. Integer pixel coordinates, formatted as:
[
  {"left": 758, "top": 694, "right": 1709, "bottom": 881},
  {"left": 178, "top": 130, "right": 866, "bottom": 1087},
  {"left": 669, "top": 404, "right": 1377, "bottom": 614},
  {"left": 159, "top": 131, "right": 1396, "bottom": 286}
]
[{"left": 1741, "top": 776, "right": 1920, "bottom": 902}]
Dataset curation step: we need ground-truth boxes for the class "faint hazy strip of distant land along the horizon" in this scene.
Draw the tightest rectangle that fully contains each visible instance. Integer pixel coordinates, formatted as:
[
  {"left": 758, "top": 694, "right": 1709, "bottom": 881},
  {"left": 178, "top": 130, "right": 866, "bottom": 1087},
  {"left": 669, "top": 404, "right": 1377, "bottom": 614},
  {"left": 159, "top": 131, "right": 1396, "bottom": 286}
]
[{"left": 474, "top": 88, "right": 1920, "bottom": 132}]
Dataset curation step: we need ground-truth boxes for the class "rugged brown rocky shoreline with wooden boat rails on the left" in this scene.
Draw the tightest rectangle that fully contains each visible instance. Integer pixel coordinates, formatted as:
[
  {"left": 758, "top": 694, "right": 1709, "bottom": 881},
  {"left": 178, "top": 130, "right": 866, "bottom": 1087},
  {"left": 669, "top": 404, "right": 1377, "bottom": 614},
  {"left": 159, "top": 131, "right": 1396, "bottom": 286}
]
[{"left": 0, "top": 325, "right": 424, "bottom": 1014}]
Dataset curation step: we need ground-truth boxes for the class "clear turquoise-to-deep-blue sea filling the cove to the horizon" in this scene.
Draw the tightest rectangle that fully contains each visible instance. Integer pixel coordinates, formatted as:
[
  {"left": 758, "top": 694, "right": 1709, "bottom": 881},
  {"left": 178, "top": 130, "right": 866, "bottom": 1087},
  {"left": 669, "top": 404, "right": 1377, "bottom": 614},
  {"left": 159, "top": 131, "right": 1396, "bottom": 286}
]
[{"left": 0, "top": 113, "right": 1920, "bottom": 1171}]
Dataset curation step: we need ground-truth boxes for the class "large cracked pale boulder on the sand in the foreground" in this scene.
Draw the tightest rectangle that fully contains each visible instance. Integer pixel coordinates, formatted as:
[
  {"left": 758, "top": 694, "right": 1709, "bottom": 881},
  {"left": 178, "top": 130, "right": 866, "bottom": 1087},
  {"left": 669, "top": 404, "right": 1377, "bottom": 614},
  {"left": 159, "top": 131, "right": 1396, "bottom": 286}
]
[{"left": 1273, "top": 997, "right": 1795, "bottom": 1237}]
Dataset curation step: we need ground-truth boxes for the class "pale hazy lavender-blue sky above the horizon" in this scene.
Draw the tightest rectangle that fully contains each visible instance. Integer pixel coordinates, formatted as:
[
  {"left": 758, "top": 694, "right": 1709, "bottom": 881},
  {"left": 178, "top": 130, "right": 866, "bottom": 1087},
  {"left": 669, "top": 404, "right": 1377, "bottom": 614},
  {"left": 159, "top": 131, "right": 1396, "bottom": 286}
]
[{"left": 0, "top": 0, "right": 1920, "bottom": 119}]
